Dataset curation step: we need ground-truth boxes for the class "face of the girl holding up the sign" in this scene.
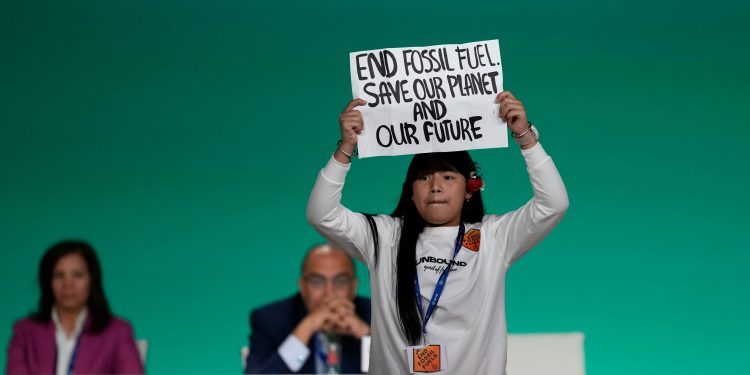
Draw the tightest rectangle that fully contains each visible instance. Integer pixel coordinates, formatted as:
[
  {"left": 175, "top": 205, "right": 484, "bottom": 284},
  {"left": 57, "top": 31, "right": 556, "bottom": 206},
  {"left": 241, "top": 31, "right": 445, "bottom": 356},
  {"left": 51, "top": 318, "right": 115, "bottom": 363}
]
[{"left": 411, "top": 171, "right": 471, "bottom": 227}]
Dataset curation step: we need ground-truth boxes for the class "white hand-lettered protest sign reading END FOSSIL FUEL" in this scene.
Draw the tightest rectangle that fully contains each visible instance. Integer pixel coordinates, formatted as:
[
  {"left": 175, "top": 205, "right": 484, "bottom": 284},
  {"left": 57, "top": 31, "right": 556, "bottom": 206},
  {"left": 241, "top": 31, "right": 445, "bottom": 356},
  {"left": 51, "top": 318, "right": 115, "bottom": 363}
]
[{"left": 349, "top": 40, "right": 508, "bottom": 158}]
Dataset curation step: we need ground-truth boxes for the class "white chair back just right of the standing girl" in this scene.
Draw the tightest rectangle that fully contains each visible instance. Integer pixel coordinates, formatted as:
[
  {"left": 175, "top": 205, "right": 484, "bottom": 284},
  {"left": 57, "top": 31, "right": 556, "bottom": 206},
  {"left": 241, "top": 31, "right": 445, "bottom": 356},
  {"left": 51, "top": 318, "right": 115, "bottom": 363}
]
[{"left": 506, "top": 332, "right": 586, "bottom": 375}]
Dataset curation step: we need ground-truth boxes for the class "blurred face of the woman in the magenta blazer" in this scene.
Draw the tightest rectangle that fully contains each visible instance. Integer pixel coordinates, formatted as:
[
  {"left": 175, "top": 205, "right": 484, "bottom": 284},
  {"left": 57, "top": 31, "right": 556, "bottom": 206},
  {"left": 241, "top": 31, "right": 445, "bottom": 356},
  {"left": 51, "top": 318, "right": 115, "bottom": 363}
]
[{"left": 52, "top": 253, "right": 91, "bottom": 311}]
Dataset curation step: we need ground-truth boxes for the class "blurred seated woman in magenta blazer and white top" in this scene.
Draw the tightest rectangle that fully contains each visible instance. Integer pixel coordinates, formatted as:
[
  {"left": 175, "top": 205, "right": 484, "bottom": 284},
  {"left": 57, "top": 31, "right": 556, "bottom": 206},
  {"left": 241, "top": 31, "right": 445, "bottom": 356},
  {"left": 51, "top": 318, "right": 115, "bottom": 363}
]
[{"left": 6, "top": 241, "right": 144, "bottom": 375}]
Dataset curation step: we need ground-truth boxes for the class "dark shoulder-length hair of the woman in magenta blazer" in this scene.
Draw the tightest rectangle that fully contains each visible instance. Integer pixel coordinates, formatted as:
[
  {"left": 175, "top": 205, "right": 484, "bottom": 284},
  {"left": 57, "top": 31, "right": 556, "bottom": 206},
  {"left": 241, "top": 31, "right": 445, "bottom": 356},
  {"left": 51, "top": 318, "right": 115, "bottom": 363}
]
[{"left": 31, "top": 240, "right": 112, "bottom": 333}]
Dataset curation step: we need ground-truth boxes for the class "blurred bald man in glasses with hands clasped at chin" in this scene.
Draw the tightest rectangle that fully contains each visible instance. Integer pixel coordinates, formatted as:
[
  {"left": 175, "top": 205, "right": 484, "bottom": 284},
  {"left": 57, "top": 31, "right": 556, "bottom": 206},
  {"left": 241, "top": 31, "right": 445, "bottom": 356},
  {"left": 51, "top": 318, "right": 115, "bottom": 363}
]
[{"left": 245, "top": 244, "right": 370, "bottom": 374}]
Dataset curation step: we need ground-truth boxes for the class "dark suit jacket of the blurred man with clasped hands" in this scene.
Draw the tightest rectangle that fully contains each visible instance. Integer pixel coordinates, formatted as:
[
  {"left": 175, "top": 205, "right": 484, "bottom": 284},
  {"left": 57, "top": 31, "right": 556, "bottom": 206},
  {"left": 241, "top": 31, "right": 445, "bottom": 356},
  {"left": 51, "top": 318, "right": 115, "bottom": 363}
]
[{"left": 245, "top": 293, "right": 370, "bottom": 374}]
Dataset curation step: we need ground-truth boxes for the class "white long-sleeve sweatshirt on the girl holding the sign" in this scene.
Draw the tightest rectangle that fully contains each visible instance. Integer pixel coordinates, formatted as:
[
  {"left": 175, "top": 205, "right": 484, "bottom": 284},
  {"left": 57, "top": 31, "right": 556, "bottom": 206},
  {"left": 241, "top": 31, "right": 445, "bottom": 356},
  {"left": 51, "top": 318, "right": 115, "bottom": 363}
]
[{"left": 307, "top": 144, "right": 568, "bottom": 374}]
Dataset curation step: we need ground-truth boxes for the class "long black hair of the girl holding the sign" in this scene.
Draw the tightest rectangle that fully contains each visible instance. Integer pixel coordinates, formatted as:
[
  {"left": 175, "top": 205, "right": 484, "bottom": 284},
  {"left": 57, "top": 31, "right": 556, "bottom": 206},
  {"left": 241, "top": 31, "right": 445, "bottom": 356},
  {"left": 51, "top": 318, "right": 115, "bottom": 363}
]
[{"left": 370, "top": 151, "right": 484, "bottom": 344}]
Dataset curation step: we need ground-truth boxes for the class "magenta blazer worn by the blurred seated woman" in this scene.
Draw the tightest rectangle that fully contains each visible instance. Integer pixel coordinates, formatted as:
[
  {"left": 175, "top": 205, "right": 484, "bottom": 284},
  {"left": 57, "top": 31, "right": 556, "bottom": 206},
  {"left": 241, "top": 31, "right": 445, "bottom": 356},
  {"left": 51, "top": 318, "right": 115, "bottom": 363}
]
[{"left": 5, "top": 317, "right": 144, "bottom": 375}]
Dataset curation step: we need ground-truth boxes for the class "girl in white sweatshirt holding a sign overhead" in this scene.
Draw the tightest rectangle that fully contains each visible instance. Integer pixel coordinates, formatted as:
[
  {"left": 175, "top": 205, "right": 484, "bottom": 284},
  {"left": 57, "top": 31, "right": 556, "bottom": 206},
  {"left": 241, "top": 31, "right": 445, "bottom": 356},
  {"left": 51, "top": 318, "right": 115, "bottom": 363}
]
[{"left": 307, "top": 91, "right": 568, "bottom": 374}]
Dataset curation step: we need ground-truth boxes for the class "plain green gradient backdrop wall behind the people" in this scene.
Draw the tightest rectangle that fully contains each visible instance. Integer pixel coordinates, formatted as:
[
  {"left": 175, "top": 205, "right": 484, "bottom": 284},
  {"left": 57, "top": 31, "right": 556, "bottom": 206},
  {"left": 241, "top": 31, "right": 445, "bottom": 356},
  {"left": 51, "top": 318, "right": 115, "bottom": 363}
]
[{"left": 0, "top": 0, "right": 750, "bottom": 375}]
